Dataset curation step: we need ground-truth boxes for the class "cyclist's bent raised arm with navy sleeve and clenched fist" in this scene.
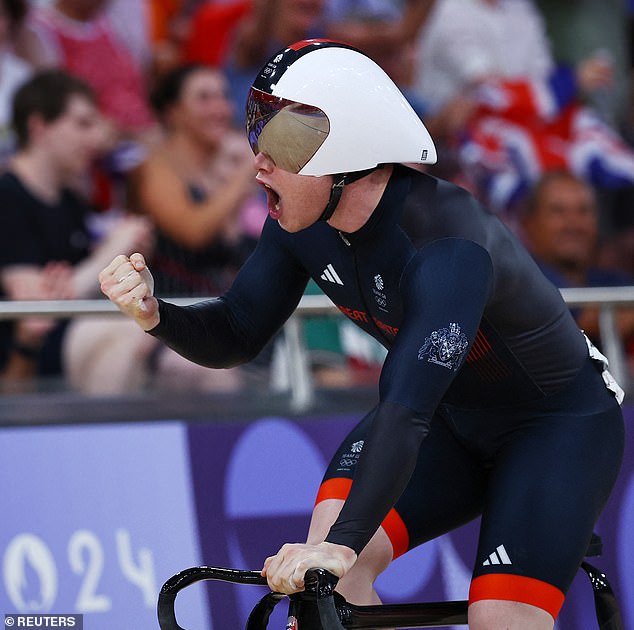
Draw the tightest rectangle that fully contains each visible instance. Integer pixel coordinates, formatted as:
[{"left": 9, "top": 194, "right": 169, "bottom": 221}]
[{"left": 100, "top": 221, "right": 308, "bottom": 367}]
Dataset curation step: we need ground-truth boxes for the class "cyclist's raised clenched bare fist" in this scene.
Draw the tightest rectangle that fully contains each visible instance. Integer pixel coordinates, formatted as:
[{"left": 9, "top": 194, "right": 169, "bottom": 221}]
[{"left": 99, "top": 254, "right": 160, "bottom": 330}]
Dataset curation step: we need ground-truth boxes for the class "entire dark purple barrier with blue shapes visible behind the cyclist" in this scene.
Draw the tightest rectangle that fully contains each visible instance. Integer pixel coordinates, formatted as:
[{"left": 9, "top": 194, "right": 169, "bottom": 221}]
[{"left": 189, "top": 409, "right": 634, "bottom": 630}]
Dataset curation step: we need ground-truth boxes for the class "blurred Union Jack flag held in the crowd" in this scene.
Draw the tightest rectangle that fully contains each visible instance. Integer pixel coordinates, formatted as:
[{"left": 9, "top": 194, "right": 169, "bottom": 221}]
[{"left": 458, "top": 70, "right": 634, "bottom": 211}]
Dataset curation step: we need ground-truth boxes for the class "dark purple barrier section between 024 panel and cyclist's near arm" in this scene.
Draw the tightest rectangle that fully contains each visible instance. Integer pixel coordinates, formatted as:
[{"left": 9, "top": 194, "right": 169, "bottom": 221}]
[{"left": 189, "top": 417, "right": 356, "bottom": 630}]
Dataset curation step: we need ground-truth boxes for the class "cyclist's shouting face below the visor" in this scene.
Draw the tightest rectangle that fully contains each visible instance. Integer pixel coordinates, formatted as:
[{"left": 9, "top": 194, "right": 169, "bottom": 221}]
[{"left": 254, "top": 153, "right": 332, "bottom": 232}]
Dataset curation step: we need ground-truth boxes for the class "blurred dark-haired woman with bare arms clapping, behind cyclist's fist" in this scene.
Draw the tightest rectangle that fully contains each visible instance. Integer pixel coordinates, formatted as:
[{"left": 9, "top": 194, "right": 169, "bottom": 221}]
[{"left": 124, "top": 64, "right": 267, "bottom": 387}]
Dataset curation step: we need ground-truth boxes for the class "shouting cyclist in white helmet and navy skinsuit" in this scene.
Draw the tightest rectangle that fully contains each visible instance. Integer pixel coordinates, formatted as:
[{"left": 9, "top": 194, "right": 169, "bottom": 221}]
[{"left": 100, "top": 40, "right": 624, "bottom": 630}]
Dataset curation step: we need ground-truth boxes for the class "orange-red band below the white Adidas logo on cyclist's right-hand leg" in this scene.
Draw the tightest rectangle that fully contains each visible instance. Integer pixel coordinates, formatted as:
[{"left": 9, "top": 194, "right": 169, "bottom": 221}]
[{"left": 469, "top": 573, "right": 565, "bottom": 619}]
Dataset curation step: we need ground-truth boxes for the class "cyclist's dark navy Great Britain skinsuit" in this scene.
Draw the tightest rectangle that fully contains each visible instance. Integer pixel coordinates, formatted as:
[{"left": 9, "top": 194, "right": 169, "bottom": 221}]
[{"left": 151, "top": 166, "right": 623, "bottom": 614}]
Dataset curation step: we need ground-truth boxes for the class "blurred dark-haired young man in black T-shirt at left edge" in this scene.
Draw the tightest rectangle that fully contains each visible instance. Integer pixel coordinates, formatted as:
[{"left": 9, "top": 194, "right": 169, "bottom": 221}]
[{"left": 0, "top": 70, "right": 151, "bottom": 387}]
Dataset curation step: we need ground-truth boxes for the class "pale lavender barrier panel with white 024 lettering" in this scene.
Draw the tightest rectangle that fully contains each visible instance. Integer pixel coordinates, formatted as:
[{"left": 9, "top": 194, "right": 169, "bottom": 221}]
[{"left": 0, "top": 423, "right": 209, "bottom": 630}]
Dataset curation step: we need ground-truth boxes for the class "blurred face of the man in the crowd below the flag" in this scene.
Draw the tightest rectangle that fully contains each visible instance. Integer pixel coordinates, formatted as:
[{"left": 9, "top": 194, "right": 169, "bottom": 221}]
[{"left": 524, "top": 178, "right": 598, "bottom": 269}]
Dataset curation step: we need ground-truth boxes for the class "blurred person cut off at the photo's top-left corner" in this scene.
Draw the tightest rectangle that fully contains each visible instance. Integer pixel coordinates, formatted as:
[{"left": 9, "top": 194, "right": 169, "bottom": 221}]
[{"left": 0, "top": 0, "right": 33, "bottom": 167}]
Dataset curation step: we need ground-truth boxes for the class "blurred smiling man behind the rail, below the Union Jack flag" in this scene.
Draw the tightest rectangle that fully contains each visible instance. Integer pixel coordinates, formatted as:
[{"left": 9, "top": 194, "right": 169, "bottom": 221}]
[{"left": 521, "top": 171, "right": 634, "bottom": 356}]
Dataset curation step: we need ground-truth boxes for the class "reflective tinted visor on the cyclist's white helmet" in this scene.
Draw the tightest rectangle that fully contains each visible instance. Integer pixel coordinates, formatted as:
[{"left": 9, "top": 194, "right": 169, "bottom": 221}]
[{"left": 246, "top": 88, "right": 330, "bottom": 173}]
